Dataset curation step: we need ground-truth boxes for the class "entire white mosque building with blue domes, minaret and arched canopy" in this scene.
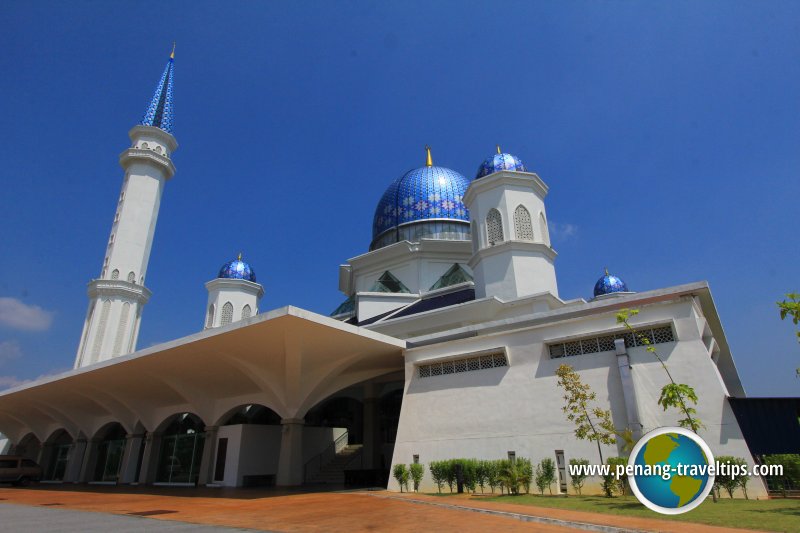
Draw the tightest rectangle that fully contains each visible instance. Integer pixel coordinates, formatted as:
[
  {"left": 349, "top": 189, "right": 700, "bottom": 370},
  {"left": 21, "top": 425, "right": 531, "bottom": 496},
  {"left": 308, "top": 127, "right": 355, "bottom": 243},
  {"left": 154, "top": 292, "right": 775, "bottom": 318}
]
[{"left": 0, "top": 52, "right": 765, "bottom": 496}]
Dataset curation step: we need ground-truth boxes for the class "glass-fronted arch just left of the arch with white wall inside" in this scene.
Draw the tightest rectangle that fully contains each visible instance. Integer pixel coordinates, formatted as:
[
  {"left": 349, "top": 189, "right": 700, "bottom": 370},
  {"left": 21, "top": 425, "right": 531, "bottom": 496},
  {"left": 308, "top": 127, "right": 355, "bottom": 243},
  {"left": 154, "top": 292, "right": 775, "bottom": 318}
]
[{"left": 156, "top": 413, "right": 205, "bottom": 485}]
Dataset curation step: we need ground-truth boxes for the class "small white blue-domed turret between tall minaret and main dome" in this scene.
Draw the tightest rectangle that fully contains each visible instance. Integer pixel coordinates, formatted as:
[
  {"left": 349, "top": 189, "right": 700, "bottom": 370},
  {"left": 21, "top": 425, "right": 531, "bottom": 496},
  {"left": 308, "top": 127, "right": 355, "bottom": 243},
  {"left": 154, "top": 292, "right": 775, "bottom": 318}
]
[{"left": 205, "top": 254, "right": 264, "bottom": 329}]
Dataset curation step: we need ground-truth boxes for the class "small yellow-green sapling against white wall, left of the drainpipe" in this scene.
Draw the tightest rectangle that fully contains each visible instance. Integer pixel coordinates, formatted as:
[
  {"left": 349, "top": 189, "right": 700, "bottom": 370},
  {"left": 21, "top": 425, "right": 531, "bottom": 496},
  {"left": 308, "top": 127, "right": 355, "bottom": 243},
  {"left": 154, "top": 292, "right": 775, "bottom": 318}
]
[{"left": 556, "top": 365, "right": 617, "bottom": 463}]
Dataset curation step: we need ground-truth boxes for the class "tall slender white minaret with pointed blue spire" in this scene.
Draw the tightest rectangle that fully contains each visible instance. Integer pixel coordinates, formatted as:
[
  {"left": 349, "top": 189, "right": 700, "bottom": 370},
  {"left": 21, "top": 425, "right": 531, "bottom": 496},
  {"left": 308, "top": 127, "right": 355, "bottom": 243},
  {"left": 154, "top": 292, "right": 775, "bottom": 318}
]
[{"left": 75, "top": 45, "right": 178, "bottom": 368}]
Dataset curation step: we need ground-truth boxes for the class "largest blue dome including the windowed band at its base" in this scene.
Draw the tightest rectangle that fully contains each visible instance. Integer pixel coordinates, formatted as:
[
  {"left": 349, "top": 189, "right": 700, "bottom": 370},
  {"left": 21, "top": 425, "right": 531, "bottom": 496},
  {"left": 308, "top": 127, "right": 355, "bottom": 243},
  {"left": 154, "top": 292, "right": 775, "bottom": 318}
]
[{"left": 370, "top": 166, "right": 470, "bottom": 250}]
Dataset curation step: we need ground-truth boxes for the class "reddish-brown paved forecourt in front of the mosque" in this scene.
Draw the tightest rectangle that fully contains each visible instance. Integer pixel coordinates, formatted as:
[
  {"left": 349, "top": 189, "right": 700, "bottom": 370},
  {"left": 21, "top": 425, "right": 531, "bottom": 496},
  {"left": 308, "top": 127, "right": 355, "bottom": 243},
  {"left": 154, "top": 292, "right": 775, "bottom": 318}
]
[{"left": 0, "top": 485, "right": 764, "bottom": 533}]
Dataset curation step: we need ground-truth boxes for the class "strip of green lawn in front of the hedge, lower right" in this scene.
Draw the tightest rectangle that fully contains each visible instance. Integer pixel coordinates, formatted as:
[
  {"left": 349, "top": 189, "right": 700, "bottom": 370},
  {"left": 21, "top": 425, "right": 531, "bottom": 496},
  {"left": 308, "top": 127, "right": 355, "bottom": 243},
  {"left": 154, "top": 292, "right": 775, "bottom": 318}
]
[{"left": 428, "top": 494, "right": 800, "bottom": 532}]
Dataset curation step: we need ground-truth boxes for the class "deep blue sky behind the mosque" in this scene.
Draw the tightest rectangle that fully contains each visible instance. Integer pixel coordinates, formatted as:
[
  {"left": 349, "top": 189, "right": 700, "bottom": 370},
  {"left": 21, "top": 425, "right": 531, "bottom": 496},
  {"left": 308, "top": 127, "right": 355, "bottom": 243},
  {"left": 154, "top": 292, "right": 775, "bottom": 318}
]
[{"left": 0, "top": 0, "right": 800, "bottom": 395}]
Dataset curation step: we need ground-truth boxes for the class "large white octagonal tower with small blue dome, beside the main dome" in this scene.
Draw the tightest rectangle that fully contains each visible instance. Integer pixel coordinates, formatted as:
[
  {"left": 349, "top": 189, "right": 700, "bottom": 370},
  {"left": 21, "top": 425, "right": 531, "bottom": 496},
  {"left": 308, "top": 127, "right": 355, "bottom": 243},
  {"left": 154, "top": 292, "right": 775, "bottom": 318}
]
[{"left": 464, "top": 146, "right": 558, "bottom": 300}]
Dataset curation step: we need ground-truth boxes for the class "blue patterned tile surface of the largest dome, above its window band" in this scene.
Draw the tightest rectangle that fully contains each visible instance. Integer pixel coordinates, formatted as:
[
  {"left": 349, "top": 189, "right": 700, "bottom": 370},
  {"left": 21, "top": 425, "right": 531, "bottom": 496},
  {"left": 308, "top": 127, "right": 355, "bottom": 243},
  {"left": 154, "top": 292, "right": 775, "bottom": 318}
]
[{"left": 372, "top": 167, "right": 470, "bottom": 246}]
